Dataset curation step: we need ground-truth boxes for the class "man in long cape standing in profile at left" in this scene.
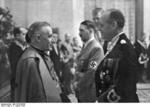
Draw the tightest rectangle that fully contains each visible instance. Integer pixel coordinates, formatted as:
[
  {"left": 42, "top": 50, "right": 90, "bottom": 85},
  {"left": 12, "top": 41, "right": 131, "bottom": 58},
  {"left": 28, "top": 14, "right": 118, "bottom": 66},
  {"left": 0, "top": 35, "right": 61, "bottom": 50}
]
[{"left": 15, "top": 22, "right": 61, "bottom": 102}]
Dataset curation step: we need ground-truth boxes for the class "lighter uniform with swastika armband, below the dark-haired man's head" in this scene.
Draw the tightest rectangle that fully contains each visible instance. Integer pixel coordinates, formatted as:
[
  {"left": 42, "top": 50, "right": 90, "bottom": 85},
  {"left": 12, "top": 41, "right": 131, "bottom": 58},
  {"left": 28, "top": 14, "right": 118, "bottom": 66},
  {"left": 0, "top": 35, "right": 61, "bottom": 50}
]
[{"left": 74, "top": 39, "right": 104, "bottom": 102}]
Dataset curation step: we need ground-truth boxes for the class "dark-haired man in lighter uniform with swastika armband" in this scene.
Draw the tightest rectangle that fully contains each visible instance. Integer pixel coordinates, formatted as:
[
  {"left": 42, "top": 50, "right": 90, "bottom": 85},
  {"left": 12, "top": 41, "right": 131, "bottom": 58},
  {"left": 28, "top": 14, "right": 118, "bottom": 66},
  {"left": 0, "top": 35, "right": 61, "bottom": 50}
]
[{"left": 73, "top": 20, "right": 104, "bottom": 102}]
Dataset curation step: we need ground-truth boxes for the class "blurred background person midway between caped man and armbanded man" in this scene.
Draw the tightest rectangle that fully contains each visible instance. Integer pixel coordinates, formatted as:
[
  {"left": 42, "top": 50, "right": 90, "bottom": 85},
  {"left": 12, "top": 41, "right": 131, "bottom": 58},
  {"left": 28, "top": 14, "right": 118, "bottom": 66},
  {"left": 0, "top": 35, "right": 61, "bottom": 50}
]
[{"left": 61, "top": 33, "right": 74, "bottom": 101}]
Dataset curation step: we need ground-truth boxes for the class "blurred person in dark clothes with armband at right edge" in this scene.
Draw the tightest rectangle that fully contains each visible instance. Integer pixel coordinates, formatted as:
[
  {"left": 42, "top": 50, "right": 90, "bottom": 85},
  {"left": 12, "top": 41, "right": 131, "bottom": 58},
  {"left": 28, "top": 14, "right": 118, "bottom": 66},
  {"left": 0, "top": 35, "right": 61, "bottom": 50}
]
[{"left": 133, "top": 33, "right": 150, "bottom": 83}]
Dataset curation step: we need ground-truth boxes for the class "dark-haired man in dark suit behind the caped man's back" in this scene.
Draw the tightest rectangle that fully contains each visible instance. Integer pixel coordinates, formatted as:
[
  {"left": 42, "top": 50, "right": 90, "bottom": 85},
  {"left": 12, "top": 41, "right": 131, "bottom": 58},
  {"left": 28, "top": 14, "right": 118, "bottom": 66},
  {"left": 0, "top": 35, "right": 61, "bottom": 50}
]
[{"left": 8, "top": 27, "right": 27, "bottom": 101}]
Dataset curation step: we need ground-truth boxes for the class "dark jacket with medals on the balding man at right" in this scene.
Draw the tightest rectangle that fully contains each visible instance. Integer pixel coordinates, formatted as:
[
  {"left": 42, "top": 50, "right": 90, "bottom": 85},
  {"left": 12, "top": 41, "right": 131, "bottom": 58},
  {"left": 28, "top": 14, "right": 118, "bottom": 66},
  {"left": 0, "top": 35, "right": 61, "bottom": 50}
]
[{"left": 95, "top": 33, "right": 138, "bottom": 102}]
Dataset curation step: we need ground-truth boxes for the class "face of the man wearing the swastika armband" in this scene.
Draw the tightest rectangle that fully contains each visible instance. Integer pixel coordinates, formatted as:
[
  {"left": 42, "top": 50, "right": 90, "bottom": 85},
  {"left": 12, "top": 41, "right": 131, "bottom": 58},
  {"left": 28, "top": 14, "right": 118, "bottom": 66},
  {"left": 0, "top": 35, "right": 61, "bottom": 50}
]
[{"left": 79, "top": 24, "right": 90, "bottom": 42}]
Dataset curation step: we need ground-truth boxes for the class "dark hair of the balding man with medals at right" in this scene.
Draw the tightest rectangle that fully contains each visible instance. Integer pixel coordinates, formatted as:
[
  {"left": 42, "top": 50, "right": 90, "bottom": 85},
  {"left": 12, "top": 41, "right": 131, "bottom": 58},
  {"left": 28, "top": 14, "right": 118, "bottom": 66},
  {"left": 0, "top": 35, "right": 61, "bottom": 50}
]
[{"left": 108, "top": 9, "right": 125, "bottom": 28}]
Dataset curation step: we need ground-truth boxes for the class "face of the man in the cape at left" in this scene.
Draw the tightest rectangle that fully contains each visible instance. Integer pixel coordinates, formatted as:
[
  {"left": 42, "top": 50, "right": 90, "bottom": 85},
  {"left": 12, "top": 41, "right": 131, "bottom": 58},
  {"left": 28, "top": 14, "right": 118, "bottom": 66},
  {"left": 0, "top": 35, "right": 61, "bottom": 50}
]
[{"left": 40, "top": 26, "right": 52, "bottom": 51}]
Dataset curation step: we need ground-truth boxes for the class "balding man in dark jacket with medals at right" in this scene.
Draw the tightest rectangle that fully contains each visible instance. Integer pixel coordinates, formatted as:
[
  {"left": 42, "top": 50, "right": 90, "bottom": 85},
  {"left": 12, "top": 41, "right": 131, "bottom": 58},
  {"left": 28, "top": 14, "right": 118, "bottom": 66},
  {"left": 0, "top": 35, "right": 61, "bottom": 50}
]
[{"left": 95, "top": 9, "right": 139, "bottom": 102}]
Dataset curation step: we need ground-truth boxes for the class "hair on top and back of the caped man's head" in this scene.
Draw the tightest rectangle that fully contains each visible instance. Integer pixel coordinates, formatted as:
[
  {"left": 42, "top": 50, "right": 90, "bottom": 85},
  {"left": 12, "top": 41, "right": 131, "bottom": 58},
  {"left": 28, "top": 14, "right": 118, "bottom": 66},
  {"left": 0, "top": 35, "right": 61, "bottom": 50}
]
[{"left": 27, "top": 22, "right": 50, "bottom": 40}]
